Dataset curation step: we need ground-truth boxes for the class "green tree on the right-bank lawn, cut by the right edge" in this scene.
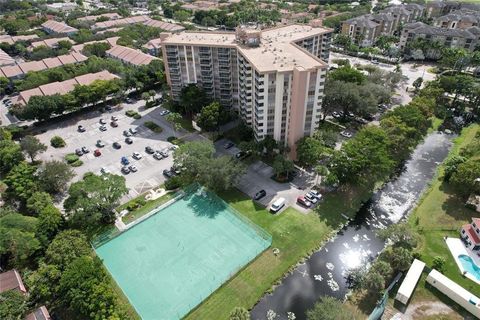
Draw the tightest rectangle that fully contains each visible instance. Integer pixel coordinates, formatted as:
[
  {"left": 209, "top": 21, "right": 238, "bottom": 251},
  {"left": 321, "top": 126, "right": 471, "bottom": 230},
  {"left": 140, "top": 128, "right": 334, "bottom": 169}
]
[{"left": 450, "top": 158, "right": 480, "bottom": 197}]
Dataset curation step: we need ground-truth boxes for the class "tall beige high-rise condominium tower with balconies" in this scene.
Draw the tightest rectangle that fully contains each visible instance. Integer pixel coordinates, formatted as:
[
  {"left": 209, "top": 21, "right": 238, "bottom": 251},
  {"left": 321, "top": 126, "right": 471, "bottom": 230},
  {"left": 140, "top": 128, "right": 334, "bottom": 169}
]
[{"left": 161, "top": 25, "right": 332, "bottom": 157}]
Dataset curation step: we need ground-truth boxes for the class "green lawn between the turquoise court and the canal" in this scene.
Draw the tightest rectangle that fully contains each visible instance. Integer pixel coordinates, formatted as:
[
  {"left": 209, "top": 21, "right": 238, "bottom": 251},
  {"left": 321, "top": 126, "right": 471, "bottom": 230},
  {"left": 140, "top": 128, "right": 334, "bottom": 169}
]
[{"left": 186, "top": 184, "right": 370, "bottom": 320}]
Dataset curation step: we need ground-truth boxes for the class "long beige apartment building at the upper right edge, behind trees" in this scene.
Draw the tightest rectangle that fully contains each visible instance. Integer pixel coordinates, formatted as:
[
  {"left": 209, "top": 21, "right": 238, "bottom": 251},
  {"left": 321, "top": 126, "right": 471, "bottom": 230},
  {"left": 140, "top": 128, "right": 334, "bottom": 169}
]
[{"left": 399, "top": 22, "right": 480, "bottom": 51}]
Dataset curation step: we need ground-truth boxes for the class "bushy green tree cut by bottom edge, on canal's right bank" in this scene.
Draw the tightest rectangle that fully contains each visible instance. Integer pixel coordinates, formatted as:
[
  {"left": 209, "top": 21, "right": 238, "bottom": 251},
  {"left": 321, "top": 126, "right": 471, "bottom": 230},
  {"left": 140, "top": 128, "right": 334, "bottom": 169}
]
[{"left": 307, "top": 296, "right": 364, "bottom": 320}]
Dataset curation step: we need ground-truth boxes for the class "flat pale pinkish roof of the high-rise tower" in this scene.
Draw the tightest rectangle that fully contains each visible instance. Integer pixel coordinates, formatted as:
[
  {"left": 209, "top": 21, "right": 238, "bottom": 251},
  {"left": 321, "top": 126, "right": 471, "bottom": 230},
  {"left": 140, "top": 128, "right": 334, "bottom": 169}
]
[{"left": 163, "top": 24, "right": 332, "bottom": 72}]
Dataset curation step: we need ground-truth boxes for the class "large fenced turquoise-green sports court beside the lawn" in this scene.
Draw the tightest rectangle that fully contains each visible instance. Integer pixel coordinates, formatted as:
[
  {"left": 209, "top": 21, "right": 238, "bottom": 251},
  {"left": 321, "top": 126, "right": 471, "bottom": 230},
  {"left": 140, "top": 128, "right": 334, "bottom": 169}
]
[{"left": 95, "top": 189, "right": 271, "bottom": 320}]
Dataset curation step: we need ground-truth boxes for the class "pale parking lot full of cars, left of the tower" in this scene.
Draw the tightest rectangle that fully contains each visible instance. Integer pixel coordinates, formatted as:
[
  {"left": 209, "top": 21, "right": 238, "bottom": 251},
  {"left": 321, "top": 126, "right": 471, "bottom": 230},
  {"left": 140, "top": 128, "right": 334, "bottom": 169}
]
[{"left": 37, "top": 101, "right": 190, "bottom": 197}]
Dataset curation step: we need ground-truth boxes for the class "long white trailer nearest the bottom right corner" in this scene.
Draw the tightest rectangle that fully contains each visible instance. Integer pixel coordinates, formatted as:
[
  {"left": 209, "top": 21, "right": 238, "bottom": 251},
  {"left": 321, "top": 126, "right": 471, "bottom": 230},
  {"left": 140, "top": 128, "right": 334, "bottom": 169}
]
[{"left": 427, "top": 269, "right": 480, "bottom": 319}]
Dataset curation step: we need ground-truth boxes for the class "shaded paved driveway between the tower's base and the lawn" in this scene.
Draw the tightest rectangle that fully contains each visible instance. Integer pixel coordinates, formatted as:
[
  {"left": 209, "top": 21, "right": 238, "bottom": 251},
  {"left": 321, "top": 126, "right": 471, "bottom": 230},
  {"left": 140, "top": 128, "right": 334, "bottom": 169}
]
[{"left": 215, "top": 139, "right": 314, "bottom": 213}]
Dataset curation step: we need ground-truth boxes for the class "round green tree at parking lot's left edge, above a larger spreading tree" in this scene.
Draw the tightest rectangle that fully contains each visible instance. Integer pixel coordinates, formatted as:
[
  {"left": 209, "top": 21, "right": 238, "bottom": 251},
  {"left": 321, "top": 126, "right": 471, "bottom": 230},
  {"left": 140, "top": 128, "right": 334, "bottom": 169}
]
[{"left": 37, "top": 160, "right": 75, "bottom": 194}]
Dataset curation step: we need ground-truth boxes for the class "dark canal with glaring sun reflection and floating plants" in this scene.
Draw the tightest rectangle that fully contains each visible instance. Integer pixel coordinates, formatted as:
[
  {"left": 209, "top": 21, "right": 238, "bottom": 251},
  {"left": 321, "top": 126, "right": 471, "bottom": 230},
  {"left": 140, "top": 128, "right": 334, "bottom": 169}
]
[{"left": 251, "top": 133, "right": 452, "bottom": 320}]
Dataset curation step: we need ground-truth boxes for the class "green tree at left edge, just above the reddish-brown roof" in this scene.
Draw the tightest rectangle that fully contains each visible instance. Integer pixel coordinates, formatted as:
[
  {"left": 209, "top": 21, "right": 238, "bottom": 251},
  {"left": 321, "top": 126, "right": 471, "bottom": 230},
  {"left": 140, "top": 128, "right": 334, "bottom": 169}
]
[{"left": 0, "top": 213, "right": 40, "bottom": 266}]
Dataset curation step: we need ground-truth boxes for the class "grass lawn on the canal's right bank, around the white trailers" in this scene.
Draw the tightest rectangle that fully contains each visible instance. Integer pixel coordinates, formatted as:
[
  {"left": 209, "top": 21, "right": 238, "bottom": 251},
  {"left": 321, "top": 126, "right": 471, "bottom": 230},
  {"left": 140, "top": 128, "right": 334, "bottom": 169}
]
[{"left": 402, "top": 125, "right": 480, "bottom": 312}]
